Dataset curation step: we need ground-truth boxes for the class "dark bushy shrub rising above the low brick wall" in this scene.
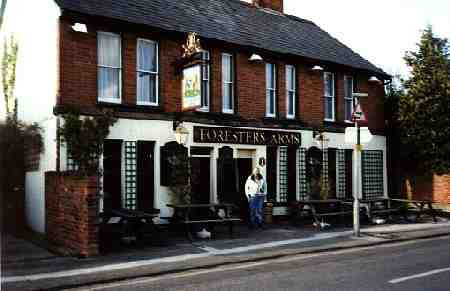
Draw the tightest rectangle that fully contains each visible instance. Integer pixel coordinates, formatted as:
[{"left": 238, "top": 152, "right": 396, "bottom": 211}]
[{"left": 59, "top": 108, "right": 117, "bottom": 175}]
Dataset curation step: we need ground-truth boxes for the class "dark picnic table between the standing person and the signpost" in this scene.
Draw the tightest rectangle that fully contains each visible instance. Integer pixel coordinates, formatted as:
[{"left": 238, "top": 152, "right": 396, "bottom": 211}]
[{"left": 291, "top": 199, "right": 352, "bottom": 229}]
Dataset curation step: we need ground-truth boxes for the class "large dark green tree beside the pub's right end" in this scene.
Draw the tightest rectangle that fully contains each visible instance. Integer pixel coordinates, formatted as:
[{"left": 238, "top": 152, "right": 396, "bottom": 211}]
[{"left": 398, "top": 26, "right": 450, "bottom": 174}]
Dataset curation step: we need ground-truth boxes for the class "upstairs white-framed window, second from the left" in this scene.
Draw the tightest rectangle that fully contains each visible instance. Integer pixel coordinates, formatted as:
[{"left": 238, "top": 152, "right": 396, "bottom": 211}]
[{"left": 136, "top": 39, "right": 159, "bottom": 106}]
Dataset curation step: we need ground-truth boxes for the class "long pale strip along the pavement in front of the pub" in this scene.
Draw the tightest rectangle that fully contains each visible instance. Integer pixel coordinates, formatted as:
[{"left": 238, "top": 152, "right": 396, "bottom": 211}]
[{"left": 1, "top": 231, "right": 352, "bottom": 283}]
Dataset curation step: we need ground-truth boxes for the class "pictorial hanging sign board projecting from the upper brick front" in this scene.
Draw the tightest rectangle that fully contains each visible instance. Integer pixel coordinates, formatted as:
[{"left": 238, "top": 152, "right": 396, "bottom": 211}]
[{"left": 182, "top": 65, "right": 202, "bottom": 111}]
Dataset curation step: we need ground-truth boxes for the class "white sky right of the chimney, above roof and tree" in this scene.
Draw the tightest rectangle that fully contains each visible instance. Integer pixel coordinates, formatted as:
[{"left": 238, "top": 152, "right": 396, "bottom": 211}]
[{"left": 284, "top": 0, "right": 450, "bottom": 77}]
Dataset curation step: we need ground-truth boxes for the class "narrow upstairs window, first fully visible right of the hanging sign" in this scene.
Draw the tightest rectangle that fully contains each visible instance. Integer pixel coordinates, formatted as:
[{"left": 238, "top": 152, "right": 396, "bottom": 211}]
[{"left": 222, "top": 54, "right": 234, "bottom": 113}]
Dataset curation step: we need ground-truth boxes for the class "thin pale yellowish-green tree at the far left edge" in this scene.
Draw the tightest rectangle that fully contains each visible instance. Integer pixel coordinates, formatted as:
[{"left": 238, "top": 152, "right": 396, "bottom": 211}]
[{"left": 2, "top": 36, "right": 19, "bottom": 121}]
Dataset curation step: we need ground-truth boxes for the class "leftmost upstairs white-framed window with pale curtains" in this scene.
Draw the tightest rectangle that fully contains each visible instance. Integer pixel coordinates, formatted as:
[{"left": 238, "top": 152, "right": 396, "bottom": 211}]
[{"left": 97, "top": 31, "right": 122, "bottom": 103}]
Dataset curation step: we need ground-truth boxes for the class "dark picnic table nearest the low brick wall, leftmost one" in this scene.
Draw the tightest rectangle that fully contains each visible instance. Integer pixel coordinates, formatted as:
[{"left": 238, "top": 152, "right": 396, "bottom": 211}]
[{"left": 100, "top": 208, "right": 160, "bottom": 248}]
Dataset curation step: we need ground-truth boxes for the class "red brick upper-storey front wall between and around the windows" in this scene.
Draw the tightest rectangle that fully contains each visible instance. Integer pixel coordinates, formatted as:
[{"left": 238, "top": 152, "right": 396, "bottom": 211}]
[{"left": 58, "top": 17, "right": 384, "bottom": 133}]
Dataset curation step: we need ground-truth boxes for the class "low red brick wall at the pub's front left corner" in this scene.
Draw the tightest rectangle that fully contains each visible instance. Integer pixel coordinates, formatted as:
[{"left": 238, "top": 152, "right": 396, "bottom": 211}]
[{"left": 45, "top": 172, "right": 99, "bottom": 257}]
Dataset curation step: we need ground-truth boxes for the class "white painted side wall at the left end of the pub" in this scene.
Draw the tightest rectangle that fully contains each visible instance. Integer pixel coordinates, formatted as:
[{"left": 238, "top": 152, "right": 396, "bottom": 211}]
[{"left": 0, "top": 0, "right": 60, "bottom": 233}]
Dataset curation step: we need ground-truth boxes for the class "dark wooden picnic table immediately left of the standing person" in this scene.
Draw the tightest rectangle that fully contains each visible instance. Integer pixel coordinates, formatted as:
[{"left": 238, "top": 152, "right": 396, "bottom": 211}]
[{"left": 167, "top": 203, "right": 241, "bottom": 241}]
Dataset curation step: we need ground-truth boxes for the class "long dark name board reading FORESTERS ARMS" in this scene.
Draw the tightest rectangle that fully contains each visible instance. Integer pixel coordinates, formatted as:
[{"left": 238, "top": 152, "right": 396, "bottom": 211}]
[{"left": 194, "top": 126, "right": 302, "bottom": 147}]
